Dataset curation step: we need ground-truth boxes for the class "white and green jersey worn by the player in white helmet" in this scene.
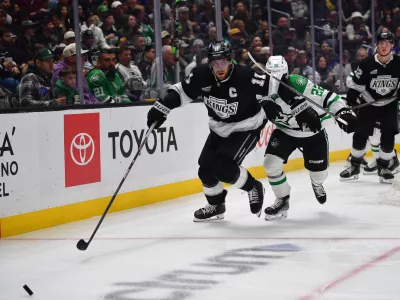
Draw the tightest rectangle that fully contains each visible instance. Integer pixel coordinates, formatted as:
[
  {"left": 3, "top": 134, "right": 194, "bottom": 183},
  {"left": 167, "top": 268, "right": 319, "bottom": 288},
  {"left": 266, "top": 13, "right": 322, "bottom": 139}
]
[{"left": 269, "top": 74, "right": 347, "bottom": 137}]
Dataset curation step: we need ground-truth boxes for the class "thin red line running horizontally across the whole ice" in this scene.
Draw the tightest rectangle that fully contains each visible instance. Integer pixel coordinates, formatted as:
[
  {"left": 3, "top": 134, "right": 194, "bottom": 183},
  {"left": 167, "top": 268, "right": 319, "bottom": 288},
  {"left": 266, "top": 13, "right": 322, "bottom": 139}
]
[{"left": 0, "top": 236, "right": 400, "bottom": 241}]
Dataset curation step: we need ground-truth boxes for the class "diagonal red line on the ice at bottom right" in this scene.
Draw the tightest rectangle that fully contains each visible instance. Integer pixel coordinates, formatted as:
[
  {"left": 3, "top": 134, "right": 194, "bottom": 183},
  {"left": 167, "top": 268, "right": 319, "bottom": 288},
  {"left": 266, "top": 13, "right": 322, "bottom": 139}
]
[{"left": 298, "top": 247, "right": 400, "bottom": 300}]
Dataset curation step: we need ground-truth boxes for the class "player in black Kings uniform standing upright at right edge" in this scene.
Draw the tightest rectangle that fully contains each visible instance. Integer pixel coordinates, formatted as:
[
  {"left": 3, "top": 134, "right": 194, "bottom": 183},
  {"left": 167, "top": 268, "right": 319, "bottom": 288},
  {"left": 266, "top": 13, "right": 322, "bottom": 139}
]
[{"left": 340, "top": 32, "right": 400, "bottom": 182}]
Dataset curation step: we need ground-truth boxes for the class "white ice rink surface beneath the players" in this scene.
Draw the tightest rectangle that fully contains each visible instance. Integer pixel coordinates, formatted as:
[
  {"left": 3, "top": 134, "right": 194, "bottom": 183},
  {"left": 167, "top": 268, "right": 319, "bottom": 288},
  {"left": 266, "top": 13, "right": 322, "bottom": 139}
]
[{"left": 0, "top": 163, "right": 400, "bottom": 300}]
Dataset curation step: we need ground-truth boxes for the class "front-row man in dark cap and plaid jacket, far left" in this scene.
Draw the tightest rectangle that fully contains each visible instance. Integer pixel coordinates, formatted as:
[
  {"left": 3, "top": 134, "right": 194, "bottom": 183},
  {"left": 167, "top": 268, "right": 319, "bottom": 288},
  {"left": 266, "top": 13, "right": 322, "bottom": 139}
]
[{"left": 19, "top": 48, "right": 66, "bottom": 107}]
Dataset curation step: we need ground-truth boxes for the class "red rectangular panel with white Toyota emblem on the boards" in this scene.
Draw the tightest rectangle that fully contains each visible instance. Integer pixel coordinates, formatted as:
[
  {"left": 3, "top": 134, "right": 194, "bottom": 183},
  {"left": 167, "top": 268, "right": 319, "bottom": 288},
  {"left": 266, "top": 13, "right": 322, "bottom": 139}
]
[{"left": 64, "top": 113, "right": 101, "bottom": 187}]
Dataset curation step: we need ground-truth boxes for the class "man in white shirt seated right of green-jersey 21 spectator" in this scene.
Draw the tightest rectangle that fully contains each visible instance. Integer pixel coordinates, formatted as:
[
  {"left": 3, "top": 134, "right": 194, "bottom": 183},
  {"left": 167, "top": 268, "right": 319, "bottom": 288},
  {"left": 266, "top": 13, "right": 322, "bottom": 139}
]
[{"left": 115, "top": 46, "right": 146, "bottom": 101}]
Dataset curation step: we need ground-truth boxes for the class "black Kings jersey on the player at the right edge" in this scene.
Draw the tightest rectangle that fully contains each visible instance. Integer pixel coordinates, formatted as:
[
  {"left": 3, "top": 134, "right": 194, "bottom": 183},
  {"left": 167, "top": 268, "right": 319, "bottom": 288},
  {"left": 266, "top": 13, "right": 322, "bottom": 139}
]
[{"left": 346, "top": 54, "right": 400, "bottom": 106}]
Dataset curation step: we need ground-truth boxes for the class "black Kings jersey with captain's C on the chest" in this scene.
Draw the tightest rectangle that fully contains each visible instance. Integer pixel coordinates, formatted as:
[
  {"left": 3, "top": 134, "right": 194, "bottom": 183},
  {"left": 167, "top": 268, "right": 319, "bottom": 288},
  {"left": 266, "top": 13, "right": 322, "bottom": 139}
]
[{"left": 163, "top": 65, "right": 296, "bottom": 137}]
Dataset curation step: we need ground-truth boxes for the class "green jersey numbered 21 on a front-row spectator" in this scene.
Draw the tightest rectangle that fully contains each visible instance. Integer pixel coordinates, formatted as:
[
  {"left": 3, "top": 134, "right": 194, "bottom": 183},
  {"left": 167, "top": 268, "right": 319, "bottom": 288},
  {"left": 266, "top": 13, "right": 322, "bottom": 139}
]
[{"left": 86, "top": 69, "right": 130, "bottom": 103}]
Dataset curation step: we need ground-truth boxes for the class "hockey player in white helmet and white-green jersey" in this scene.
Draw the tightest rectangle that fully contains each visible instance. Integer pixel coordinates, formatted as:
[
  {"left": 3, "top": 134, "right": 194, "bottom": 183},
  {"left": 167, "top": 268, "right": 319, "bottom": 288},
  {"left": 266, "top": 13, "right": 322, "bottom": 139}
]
[{"left": 264, "top": 56, "right": 357, "bottom": 220}]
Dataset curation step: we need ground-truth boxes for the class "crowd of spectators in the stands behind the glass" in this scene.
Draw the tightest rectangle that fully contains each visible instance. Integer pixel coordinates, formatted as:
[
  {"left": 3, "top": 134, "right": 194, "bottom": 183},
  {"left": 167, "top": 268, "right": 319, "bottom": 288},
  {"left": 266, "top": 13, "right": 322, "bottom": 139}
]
[{"left": 0, "top": 0, "right": 400, "bottom": 107}]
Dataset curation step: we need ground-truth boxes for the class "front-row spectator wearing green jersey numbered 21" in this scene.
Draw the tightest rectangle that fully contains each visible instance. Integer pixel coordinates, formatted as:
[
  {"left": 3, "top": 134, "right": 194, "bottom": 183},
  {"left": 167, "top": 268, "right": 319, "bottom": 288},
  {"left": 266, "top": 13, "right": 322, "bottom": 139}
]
[{"left": 86, "top": 50, "right": 130, "bottom": 103}]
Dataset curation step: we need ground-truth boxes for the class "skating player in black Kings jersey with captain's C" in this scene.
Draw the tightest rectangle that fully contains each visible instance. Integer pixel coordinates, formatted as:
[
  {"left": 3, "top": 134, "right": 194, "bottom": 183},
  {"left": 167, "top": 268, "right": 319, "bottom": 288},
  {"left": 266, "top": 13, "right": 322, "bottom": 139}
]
[{"left": 147, "top": 41, "right": 319, "bottom": 221}]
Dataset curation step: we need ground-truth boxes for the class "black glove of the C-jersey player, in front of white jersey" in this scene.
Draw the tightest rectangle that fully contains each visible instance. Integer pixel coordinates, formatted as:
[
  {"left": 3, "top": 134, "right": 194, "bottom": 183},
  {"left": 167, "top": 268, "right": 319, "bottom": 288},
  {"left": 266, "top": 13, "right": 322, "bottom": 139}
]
[{"left": 290, "top": 96, "right": 322, "bottom": 132}]
